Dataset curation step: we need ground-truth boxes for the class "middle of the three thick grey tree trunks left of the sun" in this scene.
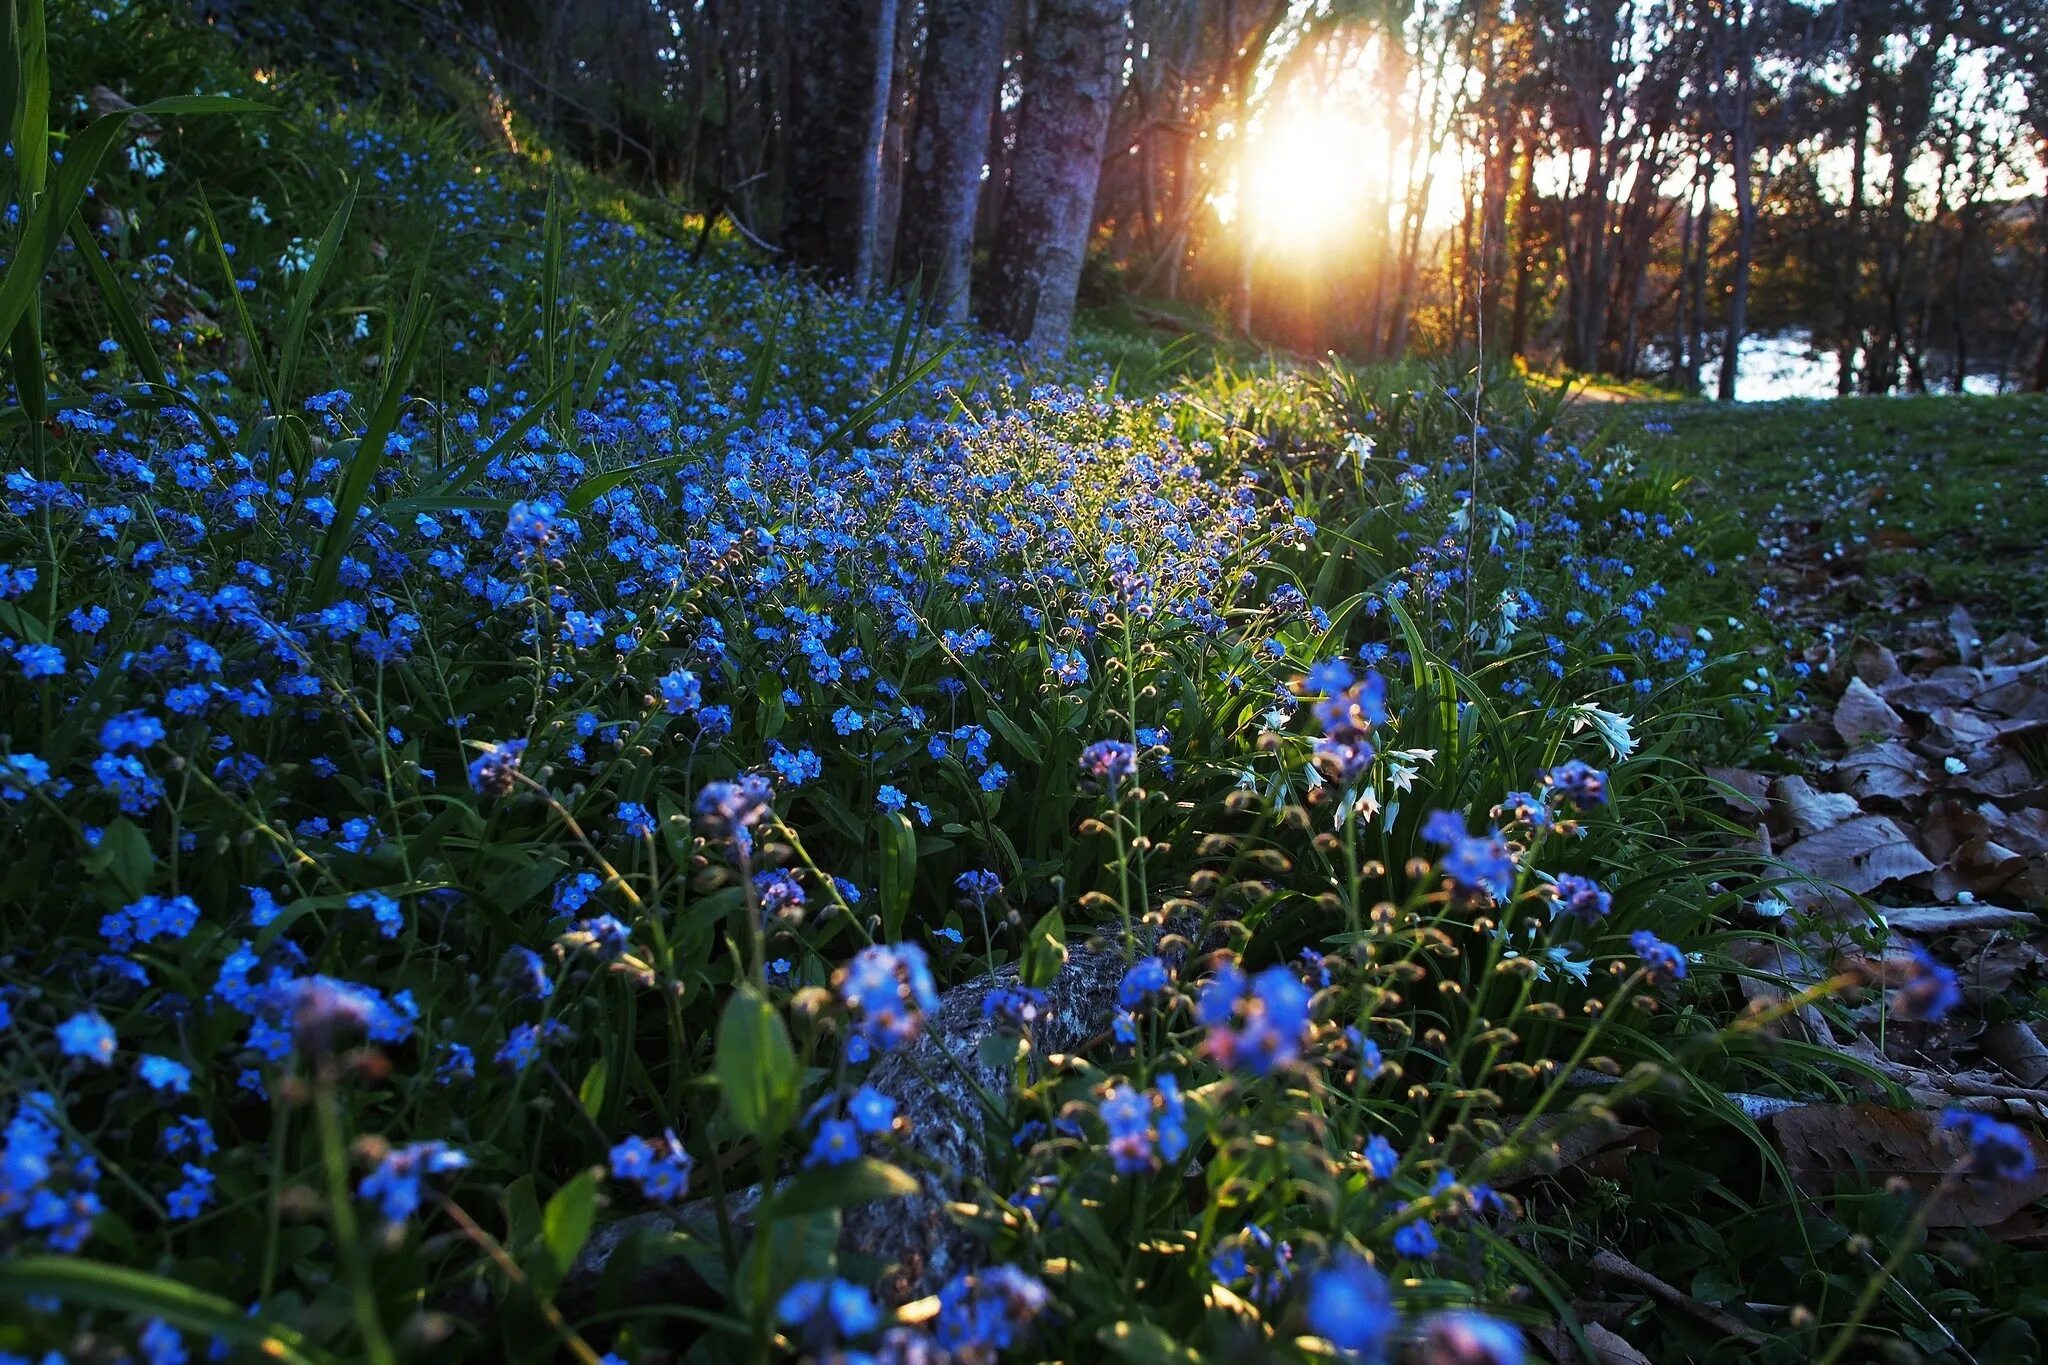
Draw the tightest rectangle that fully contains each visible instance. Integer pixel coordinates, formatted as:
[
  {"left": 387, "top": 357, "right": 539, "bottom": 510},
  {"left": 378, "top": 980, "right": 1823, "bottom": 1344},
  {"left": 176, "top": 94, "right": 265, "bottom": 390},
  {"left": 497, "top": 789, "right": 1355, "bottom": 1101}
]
[{"left": 895, "top": 0, "right": 1010, "bottom": 321}]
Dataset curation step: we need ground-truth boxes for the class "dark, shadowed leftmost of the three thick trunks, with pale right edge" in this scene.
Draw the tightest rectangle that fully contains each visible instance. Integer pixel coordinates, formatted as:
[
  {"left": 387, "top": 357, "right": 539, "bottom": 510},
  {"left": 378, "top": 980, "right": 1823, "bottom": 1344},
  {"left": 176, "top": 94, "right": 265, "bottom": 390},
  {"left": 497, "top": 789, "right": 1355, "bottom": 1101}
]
[{"left": 782, "top": 0, "right": 897, "bottom": 295}]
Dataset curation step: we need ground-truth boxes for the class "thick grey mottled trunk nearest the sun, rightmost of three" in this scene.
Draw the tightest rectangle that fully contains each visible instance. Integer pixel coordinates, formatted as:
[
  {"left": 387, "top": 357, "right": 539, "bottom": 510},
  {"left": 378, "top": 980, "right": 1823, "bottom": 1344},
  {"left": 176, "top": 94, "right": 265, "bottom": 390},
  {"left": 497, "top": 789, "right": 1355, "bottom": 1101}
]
[{"left": 983, "top": 0, "right": 1124, "bottom": 356}]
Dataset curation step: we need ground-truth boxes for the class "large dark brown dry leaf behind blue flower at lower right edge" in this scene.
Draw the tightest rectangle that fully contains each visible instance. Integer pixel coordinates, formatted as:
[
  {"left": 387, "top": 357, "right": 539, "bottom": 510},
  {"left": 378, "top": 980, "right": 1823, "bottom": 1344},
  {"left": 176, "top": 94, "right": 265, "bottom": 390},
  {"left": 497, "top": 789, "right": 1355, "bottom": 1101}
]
[{"left": 1769, "top": 1105, "right": 2048, "bottom": 1228}]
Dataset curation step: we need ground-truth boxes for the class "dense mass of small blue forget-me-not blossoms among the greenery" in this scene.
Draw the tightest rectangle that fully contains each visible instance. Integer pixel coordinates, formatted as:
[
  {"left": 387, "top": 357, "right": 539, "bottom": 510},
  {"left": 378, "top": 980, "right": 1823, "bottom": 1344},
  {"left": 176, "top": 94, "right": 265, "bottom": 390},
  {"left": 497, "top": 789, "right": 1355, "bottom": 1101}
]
[{"left": 0, "top": 29, "right": 1908, "bottom": 1365}]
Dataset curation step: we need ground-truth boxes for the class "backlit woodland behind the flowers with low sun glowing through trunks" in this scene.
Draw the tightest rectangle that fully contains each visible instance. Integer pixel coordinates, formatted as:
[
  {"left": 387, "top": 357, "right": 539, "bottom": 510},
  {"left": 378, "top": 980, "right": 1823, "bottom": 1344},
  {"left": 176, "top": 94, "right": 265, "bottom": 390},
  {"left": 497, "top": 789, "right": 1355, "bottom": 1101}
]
[{"left": 380, "top": 0, "right": 2048, "bottom": 397}]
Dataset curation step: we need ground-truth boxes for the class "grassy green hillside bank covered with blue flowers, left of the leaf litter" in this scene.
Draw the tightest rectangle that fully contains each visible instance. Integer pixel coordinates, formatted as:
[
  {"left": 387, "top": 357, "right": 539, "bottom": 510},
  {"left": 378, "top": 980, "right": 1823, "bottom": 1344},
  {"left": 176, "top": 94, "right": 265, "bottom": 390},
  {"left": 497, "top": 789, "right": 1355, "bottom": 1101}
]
[{"left": 0, "top": 4, "right": 2044, "bottom": 1365}]
